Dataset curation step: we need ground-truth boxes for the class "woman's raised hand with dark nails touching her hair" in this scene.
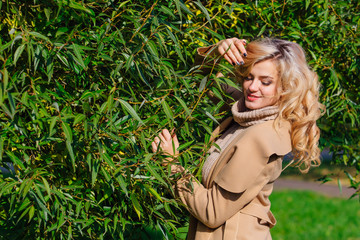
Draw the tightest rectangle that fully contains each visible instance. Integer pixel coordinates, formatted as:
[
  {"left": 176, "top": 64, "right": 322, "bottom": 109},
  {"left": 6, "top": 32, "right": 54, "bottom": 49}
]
[{"left": 214, "top": 38, "right": 247, "bottom": 65}]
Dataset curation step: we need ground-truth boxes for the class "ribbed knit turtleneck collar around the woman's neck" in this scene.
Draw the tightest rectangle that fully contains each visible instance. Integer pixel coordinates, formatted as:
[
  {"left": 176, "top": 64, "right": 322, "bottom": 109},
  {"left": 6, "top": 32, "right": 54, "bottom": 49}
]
[{"left": 231, "top": 98, "right": 279, "bottom": 127}]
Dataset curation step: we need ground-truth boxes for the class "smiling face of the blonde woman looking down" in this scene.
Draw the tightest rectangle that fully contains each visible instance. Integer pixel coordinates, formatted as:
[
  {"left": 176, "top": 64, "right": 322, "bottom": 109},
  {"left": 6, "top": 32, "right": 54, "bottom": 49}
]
[{"left": 243, "top": 59, "right": 280, "bottom": 110}]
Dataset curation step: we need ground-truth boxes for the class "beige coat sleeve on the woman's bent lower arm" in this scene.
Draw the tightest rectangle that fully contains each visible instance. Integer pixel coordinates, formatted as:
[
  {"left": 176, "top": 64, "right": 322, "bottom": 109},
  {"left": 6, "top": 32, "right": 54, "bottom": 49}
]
[{"left": 177, "top": 122, "right": 288, "bottom": 228}]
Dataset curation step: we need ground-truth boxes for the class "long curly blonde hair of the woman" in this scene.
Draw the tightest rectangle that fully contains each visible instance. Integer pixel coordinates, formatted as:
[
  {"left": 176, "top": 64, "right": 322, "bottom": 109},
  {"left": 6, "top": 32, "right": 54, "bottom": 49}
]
[{"left": 235, "top": 38, "right": 325, "bottom": 172}]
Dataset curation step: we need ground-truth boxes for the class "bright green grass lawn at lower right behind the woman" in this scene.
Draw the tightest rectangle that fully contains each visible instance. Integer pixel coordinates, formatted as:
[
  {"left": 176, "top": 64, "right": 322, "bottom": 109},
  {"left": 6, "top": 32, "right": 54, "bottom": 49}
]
[{"left": 270, "top": 190, "right": 360, "bottom": 240}]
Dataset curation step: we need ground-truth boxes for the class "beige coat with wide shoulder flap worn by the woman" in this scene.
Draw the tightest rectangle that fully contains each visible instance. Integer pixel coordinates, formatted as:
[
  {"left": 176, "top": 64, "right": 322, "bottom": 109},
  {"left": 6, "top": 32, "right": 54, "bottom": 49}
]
[{"left": 177, "top": 118, "right": 291, "bottom": 240}]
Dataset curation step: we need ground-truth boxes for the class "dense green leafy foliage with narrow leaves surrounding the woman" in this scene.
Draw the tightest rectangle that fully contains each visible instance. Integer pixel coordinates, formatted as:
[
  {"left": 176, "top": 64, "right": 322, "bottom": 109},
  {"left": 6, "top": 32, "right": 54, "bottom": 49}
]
[{"left": 0, "top": 0, "right": 360, "bottom": 239}]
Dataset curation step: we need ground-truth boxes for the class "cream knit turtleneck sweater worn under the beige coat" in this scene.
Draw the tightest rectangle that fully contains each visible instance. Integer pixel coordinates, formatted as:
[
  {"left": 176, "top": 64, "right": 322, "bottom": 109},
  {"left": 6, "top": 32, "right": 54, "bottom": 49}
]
[{"left": 202, "top": 98, "right": 279, "bottom": 181}]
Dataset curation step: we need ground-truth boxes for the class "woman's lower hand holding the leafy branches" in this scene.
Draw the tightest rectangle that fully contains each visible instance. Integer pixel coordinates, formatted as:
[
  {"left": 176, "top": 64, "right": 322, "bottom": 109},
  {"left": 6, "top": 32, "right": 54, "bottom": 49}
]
[{"left": 151, "top": 129, "right": 179, "bottom": 161}]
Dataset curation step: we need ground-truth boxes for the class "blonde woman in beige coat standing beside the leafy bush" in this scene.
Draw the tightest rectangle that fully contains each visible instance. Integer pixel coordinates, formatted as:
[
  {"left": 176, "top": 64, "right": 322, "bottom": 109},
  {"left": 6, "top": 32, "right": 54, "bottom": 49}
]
[{"left": 152, "top": 38, "right": 322, "bottom": 240}]
